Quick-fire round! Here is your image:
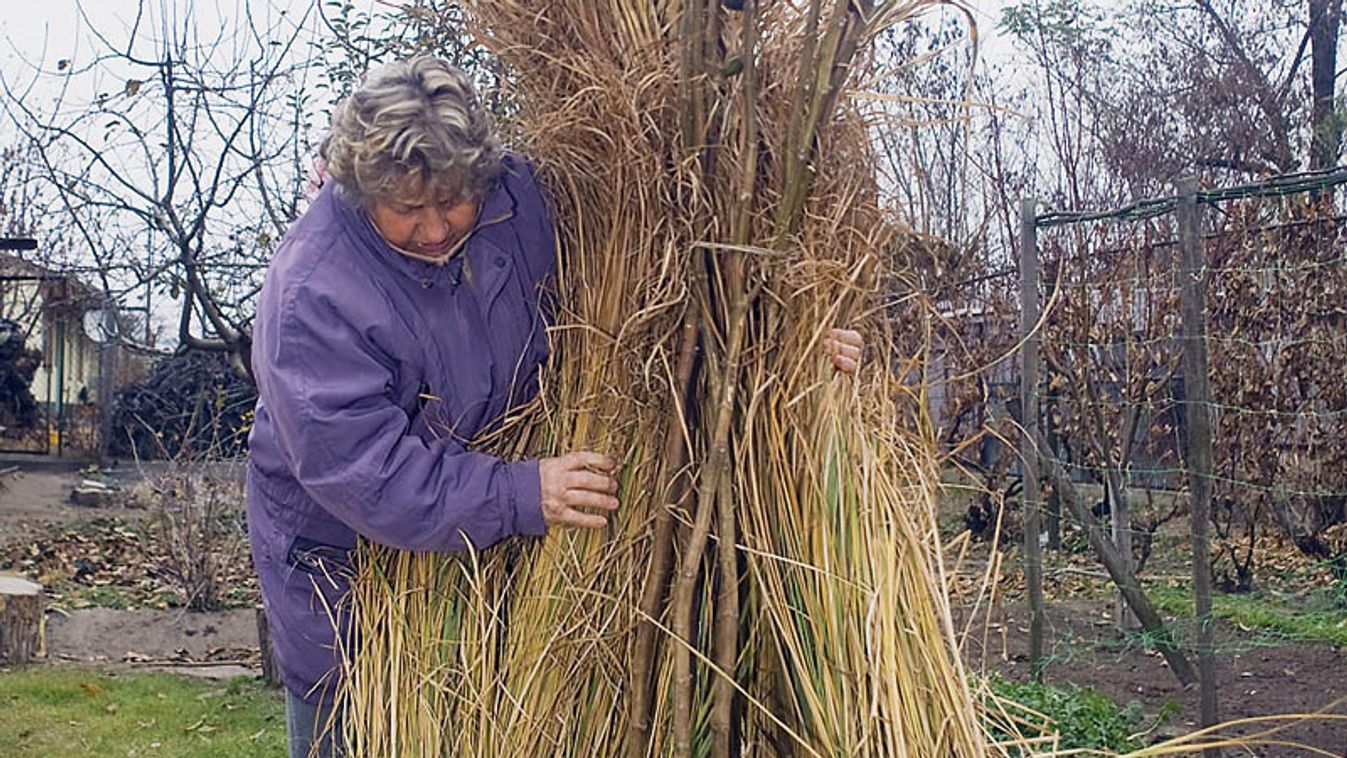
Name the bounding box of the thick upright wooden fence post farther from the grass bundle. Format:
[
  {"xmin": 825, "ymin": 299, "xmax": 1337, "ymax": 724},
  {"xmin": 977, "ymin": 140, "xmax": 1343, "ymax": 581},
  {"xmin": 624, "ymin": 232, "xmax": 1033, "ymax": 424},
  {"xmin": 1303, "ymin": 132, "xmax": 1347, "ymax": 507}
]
[{"xmin": 1177, "ymin": 178, "xmax": 1216, "ymax": 754}]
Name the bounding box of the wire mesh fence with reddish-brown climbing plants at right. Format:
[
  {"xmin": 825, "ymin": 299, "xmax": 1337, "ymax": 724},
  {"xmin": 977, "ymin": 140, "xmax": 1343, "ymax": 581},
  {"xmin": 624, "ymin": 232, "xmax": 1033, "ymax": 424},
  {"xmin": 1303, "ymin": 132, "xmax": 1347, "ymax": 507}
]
[{"xmin": 932, "ymin": 168, "xmax": 1347, "ymax": 723}]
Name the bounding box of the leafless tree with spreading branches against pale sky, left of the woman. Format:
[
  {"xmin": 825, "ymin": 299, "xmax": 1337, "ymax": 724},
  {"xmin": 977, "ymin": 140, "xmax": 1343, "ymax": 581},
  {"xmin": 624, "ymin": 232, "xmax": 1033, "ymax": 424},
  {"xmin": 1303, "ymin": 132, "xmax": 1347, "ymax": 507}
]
[{"xmin": 4, "ymin": 3, "xmax": 319, "ymax": 377}]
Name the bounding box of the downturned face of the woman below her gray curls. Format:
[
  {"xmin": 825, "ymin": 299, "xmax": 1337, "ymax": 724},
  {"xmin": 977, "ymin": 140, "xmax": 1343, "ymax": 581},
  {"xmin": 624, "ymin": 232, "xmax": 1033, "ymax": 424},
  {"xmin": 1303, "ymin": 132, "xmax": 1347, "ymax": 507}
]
[{"xmin": 369, "ymin": 182, "xmax": 478, "ymax": 259}]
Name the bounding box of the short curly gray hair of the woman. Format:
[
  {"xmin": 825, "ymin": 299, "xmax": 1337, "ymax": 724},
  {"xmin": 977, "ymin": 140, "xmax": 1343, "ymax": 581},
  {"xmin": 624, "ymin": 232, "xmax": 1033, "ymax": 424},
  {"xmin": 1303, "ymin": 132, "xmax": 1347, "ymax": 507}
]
[{"xmin": 321, "ymin": 55, "xmax": 501, "ymax": 207}]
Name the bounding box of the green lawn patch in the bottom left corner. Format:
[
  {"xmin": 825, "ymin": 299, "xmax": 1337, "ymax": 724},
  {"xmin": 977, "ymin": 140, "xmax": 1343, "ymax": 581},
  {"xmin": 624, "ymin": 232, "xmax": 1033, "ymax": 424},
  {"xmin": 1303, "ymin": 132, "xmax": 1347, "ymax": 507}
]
[{"xmin": 0, "ymin": 666, "xmax": 286, "ymax": 758}]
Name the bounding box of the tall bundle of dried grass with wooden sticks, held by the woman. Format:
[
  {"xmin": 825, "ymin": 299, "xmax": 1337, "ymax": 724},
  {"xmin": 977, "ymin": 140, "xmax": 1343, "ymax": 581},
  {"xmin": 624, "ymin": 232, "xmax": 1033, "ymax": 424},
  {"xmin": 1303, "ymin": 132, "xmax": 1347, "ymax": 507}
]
[{"xmin": 336, "ymin": 0, "xmax": 987, "ymax": 757}]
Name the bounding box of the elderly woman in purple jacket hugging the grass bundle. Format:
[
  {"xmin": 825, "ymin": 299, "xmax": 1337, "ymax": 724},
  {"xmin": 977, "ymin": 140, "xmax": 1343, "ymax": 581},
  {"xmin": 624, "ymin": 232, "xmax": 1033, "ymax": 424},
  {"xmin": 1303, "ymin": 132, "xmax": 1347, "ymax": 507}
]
[{"xmin": 248, "ymin": 58, "xmax": 859, "ymax": 755}]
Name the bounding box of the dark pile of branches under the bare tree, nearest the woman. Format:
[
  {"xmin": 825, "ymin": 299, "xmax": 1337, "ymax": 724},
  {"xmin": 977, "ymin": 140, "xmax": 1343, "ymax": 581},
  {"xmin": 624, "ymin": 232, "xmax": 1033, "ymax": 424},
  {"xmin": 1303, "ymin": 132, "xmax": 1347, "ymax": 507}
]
[{"xmin": 109, "ymin": 350, "xmax": 257, "ymax": 459}]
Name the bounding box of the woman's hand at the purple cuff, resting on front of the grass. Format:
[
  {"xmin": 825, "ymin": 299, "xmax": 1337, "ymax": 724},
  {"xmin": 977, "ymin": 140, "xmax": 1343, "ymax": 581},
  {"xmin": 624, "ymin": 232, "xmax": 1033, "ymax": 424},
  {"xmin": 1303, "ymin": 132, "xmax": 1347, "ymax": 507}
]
[{"xmin": 537, "ymin": 452, "xmax": 617, "ymax": 529}]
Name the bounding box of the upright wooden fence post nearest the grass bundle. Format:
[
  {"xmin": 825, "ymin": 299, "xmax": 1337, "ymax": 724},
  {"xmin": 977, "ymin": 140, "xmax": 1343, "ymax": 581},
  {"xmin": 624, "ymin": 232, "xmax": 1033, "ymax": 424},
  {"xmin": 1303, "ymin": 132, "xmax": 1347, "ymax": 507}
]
[{"xmin": 1020, "ymin": 198, "xmax": 1044, "ymax": 679}]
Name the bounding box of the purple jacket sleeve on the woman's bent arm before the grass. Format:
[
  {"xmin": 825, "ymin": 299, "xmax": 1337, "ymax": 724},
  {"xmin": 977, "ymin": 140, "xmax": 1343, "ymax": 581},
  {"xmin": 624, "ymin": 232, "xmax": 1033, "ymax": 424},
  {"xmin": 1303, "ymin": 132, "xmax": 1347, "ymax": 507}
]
[{"xmin": 259, "ymin": 285, "xmax": 547, "ymax": 551}]
